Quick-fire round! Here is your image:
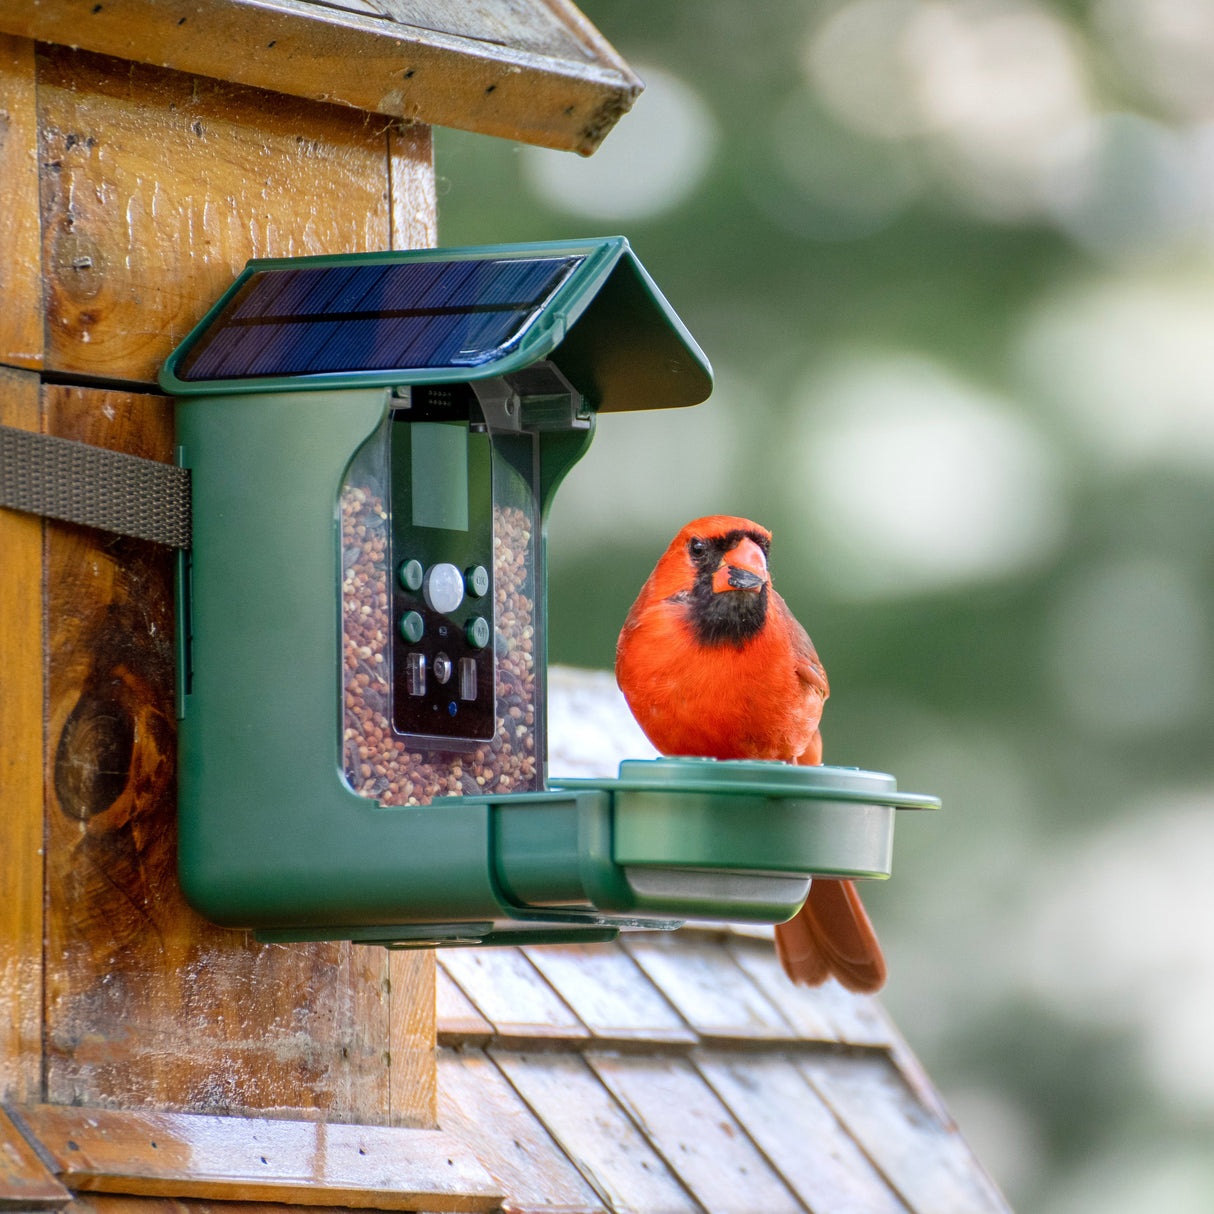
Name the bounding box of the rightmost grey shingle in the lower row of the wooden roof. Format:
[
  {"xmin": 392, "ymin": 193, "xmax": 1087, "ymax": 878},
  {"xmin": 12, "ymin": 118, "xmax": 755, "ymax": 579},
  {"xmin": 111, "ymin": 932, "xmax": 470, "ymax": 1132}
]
[{"xmin": 799, "ymin": 1056, "xmax": 1010, "ymax": 1214}]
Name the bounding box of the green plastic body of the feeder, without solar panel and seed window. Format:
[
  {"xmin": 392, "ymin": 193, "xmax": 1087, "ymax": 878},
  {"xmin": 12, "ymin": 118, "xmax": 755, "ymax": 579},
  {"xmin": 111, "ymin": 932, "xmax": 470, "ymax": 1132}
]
[{"xmin": 161, "ymin": 238, "xmax": 936, "ymax": 947}]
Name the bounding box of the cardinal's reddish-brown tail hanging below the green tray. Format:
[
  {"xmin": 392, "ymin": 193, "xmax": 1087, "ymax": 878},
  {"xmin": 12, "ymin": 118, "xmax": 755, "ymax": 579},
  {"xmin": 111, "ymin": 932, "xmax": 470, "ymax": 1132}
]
[{"xmin": 776, "ymin": 877, "xmax": 885, "ymax": 994}]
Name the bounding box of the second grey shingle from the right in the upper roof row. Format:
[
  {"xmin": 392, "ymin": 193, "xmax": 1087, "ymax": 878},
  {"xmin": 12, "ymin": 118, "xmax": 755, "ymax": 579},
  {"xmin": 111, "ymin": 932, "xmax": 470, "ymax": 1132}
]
[{"xmin": 620, "ymin": 932, "xmax": 796, "ymax": 1042}]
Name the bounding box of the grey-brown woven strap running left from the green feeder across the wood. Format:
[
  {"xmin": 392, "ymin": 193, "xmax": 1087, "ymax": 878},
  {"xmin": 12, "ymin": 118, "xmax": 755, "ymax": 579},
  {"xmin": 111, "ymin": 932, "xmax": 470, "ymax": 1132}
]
[{"xmin": 0, "ymin": 426, "xmax": 191, "ymax": 548}]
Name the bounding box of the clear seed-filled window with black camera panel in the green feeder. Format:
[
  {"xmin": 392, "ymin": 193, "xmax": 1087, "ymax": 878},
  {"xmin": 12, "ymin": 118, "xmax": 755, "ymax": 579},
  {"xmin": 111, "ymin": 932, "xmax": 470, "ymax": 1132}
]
[{"xmin": 339, "ymin": 385, "xmax": 545, "ymax": 805}]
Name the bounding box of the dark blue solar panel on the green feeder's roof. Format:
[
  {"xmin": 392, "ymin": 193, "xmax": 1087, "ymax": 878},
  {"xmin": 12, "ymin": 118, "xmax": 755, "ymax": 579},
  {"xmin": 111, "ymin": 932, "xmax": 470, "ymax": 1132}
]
[{"xmin": 178, "ymin": 256, "xmax": 585, "ymax": 381}]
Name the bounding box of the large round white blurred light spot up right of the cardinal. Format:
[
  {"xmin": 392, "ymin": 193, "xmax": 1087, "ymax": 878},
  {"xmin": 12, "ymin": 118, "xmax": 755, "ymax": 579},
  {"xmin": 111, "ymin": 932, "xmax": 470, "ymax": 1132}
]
[{"xmin": 787, "ymin": 354, "xmax": 1066, "ymax": 596}]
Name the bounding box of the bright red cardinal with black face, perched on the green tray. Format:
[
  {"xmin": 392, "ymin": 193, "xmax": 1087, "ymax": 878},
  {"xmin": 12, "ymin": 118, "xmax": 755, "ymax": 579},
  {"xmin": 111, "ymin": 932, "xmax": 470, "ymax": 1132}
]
[{"xmin": 615, "ymin": 515, "xmax": 885, "ymax": 994}]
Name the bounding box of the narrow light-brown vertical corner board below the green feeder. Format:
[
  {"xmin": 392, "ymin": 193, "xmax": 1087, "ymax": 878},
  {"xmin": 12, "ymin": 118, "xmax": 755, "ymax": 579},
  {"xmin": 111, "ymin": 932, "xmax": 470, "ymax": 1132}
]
[{"xmin": 388, "ymin": 951, "xmax": 438, "ymax": 1129}]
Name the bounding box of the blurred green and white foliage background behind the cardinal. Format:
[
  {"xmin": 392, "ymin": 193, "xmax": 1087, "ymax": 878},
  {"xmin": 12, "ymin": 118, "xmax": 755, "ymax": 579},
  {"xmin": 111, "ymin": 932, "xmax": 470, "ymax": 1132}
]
[{"xmin": 437, "ymin": 0, "xmax": 1214, "ymax": 1214}]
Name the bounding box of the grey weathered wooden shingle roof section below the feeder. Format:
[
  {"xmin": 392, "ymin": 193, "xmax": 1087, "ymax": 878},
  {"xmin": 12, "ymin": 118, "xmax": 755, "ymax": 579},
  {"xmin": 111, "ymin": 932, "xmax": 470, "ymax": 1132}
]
[{"xmin": 438, "ymin": 927, "xmax": 1008, "ymax": 1214}]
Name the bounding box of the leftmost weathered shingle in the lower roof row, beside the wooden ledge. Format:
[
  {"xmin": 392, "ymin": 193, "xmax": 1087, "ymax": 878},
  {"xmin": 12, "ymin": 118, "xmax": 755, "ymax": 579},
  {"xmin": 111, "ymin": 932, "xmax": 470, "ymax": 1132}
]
[{"xmin": 438, "ymin": 1050, "xmax": 607, "ymax": 1214}]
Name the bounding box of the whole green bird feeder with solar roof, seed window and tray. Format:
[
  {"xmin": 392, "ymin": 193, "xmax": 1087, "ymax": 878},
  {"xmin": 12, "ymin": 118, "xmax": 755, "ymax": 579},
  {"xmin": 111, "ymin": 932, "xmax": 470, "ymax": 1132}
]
[{"xmin": 161, "ymin": 231, "xmax": 934, "ymax": 947}]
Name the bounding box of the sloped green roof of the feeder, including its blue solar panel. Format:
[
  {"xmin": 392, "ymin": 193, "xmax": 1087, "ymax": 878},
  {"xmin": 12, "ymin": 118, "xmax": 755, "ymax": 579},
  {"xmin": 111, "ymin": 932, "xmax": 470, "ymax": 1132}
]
[{"xmin": 160, "ymin": 237, "xmax": 713, "ymax": 412}]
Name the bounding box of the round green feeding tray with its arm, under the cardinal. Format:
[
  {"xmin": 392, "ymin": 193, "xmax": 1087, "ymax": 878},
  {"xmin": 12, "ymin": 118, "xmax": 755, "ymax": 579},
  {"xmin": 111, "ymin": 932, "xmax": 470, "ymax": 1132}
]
[{"xmin": 497, "ymin": 758, "xmax": 940, "ymax": 923}]
